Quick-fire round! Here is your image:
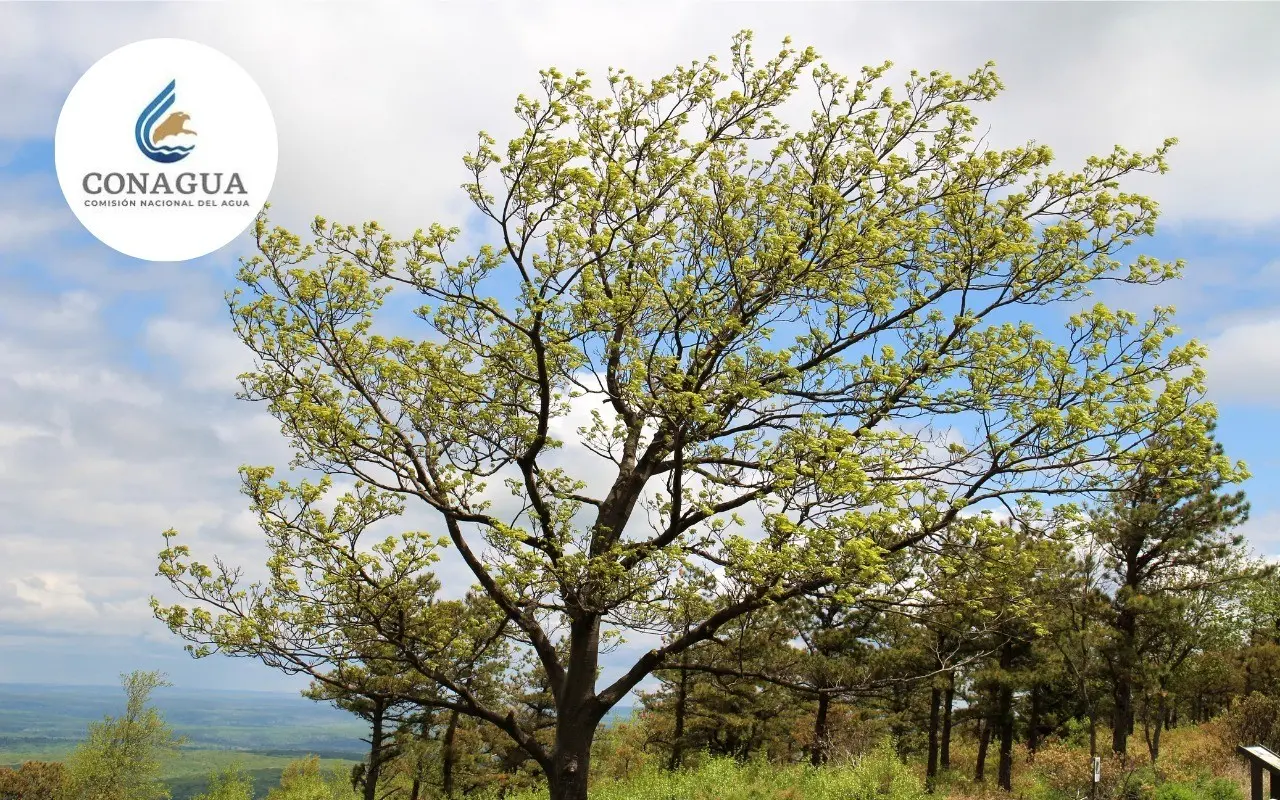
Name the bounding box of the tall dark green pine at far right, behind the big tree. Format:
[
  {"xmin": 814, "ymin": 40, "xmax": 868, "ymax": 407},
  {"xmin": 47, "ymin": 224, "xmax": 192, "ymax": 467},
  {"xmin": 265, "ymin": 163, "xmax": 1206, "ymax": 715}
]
[{"xmin": 1092, "ymin": 421, "xmax": 1254, "ymax": 759}]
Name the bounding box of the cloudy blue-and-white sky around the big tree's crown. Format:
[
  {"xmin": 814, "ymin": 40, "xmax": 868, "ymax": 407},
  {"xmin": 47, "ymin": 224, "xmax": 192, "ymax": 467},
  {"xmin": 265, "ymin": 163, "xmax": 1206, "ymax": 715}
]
[{"xmin": 0, "ymin": 3, "xmax": 1280, "ymax": 689}]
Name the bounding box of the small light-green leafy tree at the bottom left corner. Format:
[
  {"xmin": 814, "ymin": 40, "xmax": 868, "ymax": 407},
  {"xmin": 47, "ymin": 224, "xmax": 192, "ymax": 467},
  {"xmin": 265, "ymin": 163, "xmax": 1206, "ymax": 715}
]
[{"xmin": 58, "ymin": 672, "xmax": 184, "ymax": 800}]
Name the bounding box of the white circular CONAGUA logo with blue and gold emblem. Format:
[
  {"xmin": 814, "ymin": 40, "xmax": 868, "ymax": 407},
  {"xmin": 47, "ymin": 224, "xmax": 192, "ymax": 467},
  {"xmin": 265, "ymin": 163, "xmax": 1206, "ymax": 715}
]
[{"xmin": 54, "ymin": 38, "xmax": 279, "ymax": 261}]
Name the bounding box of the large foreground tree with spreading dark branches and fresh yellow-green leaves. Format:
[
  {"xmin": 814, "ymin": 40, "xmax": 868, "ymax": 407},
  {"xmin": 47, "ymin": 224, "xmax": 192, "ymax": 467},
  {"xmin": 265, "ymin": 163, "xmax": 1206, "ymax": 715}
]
[{"xmin": 154, "ymin": 35, "xmax": 1202, "ymax": 800}]
